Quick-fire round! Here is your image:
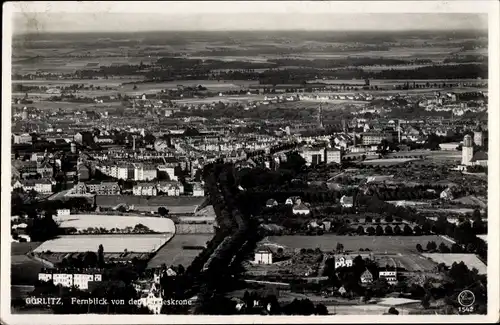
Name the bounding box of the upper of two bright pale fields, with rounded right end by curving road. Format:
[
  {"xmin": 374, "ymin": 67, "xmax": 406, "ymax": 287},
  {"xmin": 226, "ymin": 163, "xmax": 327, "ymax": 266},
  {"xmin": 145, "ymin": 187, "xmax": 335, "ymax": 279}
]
[{"xmin": 54, "ymin": 214, "xmax": 175, "ymax": 233}]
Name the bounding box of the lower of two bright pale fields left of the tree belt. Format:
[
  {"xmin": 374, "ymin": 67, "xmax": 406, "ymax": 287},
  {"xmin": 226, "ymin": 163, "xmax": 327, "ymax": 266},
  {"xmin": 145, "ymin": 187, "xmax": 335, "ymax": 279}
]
[{"xmin": 34, "ymin": 234, "xmax": 173, "ymax": 253}]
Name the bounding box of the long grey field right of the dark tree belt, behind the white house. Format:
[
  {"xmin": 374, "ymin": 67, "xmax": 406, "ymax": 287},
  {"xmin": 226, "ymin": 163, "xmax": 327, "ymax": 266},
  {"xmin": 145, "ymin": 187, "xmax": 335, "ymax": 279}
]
[{"xmin": 261, "ymin": 234, "xmax": 446, "ymax": 253}]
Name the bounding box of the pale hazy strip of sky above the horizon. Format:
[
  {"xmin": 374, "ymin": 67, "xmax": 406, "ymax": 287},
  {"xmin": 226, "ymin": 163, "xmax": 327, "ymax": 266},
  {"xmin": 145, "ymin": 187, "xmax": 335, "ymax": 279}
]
[{"xmin": 14, "ymin": 12, "xmax": 488, "ymax": 33}]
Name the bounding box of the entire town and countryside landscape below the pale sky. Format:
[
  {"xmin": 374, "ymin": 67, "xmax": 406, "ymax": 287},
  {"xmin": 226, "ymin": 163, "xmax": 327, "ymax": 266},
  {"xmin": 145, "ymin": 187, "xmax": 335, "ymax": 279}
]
[{"xmin": 9, "ymin": 12, "xmax": 489, "ymax": 315}]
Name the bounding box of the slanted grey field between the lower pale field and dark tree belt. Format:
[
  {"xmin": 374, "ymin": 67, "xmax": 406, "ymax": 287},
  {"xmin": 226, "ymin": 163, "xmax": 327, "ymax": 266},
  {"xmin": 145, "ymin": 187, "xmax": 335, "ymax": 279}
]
[{"xmin": 148, "ymin": 234, "xmax": 212, "ymax": 268}]
